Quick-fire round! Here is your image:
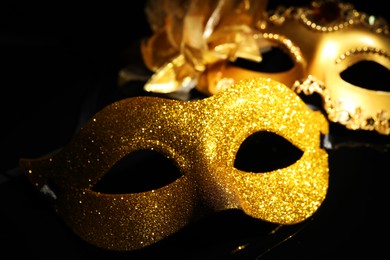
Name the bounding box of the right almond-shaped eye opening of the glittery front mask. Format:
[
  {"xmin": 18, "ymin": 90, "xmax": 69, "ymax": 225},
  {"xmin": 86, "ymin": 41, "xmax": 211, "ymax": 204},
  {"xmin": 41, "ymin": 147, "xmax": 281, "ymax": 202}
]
[{"xmin": 234, "ymin": 131, "xmax": 303, "ymax": 173}]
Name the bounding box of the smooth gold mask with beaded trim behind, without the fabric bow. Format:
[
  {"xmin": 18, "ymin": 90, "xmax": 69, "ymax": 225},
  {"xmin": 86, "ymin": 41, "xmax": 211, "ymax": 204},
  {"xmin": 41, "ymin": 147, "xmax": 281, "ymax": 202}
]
[{"xmin": 198, "ymin": 0, "xmax": 390, "ymax": 135}]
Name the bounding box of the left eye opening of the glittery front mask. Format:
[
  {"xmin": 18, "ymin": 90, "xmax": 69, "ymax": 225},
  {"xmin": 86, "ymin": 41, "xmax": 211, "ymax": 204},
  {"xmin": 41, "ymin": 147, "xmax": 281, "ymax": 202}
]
[{"xmin": 91, "ymin": 149, "xmax": 182, "ymax": 194}]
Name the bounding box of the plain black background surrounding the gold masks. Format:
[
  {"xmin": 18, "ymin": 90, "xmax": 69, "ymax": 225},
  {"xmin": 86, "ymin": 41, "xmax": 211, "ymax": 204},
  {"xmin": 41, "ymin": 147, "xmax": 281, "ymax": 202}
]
[{"xmin": 0, "ymin": 0, "xmax": 390, "ymax": 259}]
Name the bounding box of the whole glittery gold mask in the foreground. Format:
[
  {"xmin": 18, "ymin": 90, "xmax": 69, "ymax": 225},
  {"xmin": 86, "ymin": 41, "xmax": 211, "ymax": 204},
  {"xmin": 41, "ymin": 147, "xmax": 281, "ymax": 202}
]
[{"xmin": 20, "ymin": 79, "xmax": 328, "ymax": 251}]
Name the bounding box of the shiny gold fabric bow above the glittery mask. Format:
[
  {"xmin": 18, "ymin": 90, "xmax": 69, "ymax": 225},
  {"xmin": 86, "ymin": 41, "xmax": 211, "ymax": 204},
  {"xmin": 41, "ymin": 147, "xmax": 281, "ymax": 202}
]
[{"xmin": 120, "ymin": 0, "xmax": 267, "ymax": 96}]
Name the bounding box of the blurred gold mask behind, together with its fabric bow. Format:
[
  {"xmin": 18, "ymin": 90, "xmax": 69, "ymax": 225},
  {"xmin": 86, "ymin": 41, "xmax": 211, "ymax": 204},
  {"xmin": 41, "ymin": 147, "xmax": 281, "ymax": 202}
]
[{"xmin": 124, "ymin": 0, "xmax": 390, "ymax": 135}]
